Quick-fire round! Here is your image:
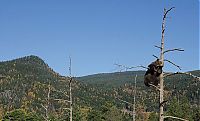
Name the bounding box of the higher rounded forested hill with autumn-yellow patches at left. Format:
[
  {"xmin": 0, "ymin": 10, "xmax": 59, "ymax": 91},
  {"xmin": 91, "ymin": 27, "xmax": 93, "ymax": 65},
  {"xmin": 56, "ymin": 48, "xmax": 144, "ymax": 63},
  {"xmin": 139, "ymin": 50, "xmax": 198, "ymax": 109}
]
[{"xmin": 0, "ymin": 55, "xmax": 77, "ymax": 120}]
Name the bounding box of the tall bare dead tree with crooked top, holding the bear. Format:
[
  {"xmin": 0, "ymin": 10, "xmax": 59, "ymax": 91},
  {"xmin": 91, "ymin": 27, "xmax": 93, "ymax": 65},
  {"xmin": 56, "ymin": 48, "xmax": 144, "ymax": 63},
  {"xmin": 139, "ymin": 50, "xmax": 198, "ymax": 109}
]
[{"xmin": 115, "ymin": 7, "xmax": 200, "ymax": 121}]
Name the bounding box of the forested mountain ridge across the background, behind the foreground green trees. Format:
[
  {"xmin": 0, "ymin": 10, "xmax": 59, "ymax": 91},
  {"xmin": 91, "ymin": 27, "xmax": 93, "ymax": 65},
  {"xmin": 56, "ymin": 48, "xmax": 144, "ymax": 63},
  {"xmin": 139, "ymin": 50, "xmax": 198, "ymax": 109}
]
[{"xmin": 0, "ymin": 56, "xmax": 200, "ymax": 120}]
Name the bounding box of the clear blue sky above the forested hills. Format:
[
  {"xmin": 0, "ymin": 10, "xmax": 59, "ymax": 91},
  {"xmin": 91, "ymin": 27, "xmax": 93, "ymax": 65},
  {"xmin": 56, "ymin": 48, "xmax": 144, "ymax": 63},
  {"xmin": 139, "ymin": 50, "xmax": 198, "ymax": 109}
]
[{"xmin": 0, "ymin": 0, "xmax": 199, "ymax": 76}]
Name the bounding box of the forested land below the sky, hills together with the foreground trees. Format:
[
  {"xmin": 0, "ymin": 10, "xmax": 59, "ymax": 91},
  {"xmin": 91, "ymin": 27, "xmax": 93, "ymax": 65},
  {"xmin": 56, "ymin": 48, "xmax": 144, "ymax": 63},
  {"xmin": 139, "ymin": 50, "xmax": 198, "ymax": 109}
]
[{"xmin": 0, "ymin": 56, "xmax": 200, "ymax": 121}]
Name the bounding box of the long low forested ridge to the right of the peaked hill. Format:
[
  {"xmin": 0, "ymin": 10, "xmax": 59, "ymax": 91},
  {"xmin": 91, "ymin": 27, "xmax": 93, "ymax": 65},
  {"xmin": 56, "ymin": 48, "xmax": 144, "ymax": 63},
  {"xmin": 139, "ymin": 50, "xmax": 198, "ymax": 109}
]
[{"xmin": 77, "ymin": 70, "xmax": 200, "ymax": 108}]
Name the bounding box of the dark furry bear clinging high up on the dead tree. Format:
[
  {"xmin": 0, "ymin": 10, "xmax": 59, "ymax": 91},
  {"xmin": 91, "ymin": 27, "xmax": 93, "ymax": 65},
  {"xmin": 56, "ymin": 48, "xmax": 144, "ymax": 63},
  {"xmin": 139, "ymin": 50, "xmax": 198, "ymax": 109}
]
[{"xmin": 144, "ymin": 59, "xmax": 163, "ymax": 87}]
